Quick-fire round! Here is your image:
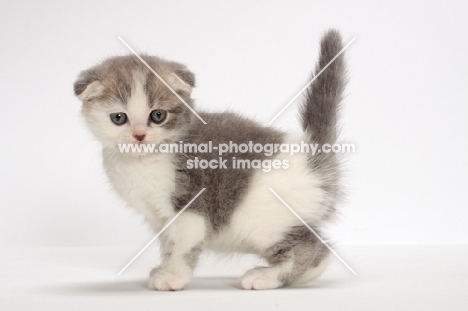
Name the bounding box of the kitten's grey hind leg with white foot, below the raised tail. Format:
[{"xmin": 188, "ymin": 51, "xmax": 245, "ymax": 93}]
[{"xmin": 241, "ymin": 227, "xmax": 323, "ymax": 289}]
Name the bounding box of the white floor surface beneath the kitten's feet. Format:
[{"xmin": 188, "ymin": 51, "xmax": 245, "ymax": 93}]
[{"xmin": 0, "ymin": 245, "xmax": 468, "ymax": 311}]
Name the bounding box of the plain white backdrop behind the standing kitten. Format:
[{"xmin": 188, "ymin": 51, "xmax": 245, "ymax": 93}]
[{"xmin": 0, "ymin": 0, "xmax": 468, "ymax": 247}]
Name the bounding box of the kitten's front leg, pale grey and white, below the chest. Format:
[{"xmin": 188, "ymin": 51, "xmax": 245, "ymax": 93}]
[{"xmin": 148, "ymin": 211, "xmax": 205, "ymax": 290}]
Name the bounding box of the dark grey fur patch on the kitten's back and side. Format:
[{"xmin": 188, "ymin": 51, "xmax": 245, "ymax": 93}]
[{"xmin": 173, "ymin": 113, "xmax": 284, "ymax": 231}]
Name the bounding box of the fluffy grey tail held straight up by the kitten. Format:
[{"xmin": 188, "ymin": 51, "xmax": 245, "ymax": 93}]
[{"xmin": 301, "ymin": 30, "xmax": 346, "ymax": 145}]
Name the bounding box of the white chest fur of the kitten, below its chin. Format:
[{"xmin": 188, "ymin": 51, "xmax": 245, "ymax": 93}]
[{"xmin": 103, "ymin": 149, "xmax": 175, "ymax": 227}]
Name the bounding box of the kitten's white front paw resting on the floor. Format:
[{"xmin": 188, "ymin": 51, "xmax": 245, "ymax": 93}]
[{"xmin": 148, "ymin": 268, "xmax": 191, "ymax": 291}]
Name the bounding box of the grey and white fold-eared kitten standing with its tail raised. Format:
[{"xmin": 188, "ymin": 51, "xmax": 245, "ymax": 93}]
[{"xmin": 74, "ymin": 30, "xmax": 345, "ymax": 290}]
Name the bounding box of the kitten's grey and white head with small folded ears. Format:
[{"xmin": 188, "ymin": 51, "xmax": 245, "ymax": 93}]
[{"xmin": 74, "ymin": 55, "xmax": 195, "ymax": 153}]
